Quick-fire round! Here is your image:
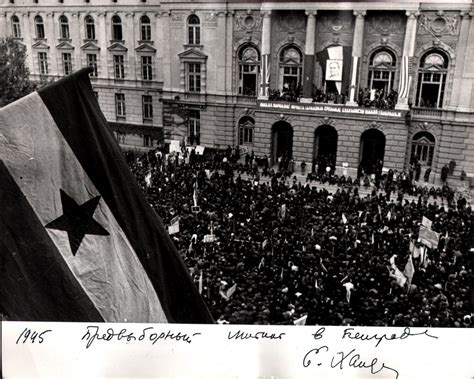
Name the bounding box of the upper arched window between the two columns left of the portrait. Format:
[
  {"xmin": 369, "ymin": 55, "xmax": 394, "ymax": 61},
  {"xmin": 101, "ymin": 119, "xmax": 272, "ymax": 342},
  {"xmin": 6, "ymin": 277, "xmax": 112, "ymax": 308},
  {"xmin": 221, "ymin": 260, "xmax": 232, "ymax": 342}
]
[{"xmin": 280, "ymin": 46, "xmax": 303, "ymax": 93}]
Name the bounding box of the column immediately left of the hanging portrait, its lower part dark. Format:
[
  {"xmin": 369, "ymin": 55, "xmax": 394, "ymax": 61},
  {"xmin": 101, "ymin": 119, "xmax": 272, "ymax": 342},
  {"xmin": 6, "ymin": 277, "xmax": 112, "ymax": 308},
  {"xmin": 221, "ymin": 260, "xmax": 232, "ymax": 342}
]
[{"xmin": 301, "ymin": 11, "xmax": 318, "ymax": 103}]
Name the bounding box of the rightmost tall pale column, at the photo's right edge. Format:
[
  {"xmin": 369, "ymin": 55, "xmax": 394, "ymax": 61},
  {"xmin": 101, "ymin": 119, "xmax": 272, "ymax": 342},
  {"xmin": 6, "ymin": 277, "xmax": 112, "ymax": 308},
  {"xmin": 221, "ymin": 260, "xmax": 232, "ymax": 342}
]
[{"xmin": 449, "ymin": 11, "xmax": 473, "ymax": 111}]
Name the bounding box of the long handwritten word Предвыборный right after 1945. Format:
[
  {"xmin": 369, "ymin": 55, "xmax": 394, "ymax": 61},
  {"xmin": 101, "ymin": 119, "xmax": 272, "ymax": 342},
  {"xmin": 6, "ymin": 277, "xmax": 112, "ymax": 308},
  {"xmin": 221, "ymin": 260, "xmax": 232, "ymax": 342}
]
[{"xmin": 81, "ymin": 326, "xmax": 201, "ymax": 349}]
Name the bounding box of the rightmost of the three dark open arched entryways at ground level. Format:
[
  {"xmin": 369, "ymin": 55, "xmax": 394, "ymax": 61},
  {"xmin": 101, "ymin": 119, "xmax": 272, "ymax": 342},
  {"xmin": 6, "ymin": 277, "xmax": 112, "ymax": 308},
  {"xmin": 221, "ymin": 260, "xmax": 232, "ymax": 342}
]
[{"xmin": 359, "ymin": 129, "xmax": 385, "ymax": 176}]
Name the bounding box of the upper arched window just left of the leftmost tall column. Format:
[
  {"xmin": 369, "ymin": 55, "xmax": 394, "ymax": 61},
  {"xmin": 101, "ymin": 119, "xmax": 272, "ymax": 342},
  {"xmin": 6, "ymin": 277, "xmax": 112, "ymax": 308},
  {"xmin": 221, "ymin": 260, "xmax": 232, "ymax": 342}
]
[{"xmin": 239, "ymin": 45, "xmax": 260, "ymax": 96}]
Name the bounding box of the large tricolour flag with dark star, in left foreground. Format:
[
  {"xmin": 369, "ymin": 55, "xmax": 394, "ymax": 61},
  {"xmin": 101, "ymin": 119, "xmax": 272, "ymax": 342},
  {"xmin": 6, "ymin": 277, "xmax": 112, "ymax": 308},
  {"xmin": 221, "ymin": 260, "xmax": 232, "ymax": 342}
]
[{"xmin": 0, "ymin": 69, "xmax": 213, "ymax": 323}]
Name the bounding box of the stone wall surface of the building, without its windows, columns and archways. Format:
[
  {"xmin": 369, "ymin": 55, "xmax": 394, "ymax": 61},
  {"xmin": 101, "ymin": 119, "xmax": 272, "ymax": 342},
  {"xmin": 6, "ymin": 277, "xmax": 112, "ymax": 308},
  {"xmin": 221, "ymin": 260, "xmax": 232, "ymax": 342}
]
[{"xmin": 0, "ymin": 0, "xmax": 474, "ymax": 181}]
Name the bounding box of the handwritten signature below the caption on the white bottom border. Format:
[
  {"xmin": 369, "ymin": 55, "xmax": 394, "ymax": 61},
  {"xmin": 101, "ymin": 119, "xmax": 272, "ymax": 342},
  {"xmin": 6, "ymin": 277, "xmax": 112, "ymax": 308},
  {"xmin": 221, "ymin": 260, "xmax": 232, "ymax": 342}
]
[{"xmin": 303, "ymin": 345, "xmax": 399, "ymax": 379}]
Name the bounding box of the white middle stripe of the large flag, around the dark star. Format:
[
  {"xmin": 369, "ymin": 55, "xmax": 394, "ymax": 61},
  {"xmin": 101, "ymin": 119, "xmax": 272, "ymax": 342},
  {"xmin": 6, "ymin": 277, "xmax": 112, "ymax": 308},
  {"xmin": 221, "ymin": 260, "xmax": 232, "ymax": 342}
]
[{"xmin": 0, "ymin": 93, "xmax": 167, "ymax": 322}]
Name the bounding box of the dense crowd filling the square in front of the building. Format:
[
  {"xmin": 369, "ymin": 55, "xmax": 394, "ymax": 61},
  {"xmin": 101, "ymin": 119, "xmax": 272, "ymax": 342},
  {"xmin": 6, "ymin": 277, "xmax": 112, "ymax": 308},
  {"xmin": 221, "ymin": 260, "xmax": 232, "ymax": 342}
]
[{"xmin": 128, "ymin": 147, "xmax": 474, "ymax": 327}]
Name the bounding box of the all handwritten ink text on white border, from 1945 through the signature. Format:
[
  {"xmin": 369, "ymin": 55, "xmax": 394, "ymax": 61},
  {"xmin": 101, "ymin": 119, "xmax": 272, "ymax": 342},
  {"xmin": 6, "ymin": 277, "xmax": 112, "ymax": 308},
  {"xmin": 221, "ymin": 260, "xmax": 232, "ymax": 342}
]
[{"xmin": 12, "ymin": 325, "xmax": 438, "ymax": 379}]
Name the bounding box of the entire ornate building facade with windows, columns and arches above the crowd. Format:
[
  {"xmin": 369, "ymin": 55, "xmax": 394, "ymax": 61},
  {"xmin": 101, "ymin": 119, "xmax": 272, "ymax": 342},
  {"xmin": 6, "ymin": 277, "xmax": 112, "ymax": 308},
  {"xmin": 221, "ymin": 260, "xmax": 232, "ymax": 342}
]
[{"xmin": 0, "ymin": 0, "xmax": 474, "ymax": 181}]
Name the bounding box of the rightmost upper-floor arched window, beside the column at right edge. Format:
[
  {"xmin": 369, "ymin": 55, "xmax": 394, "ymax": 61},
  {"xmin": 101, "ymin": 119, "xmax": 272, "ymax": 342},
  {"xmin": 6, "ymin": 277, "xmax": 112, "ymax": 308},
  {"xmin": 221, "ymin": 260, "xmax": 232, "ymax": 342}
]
[{"xmin": 415, "ymin": 50, "xmax": 449, "ymax": 108}]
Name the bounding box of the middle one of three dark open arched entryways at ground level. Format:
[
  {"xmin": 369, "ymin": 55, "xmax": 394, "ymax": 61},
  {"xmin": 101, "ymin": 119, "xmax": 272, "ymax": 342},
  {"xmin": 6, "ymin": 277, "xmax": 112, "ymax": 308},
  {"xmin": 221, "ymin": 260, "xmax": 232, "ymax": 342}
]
[{"xmin": 313, "ymin": 125, "xmax": 337, "ymax": 174}]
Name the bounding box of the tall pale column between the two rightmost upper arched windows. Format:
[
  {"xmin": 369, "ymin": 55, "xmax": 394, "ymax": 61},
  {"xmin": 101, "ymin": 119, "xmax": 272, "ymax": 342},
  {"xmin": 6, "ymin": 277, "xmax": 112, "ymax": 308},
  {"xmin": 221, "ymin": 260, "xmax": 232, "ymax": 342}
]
[{"xmin": 395, "ymin": 11, "xmax": 419, "ymax": 110}]
